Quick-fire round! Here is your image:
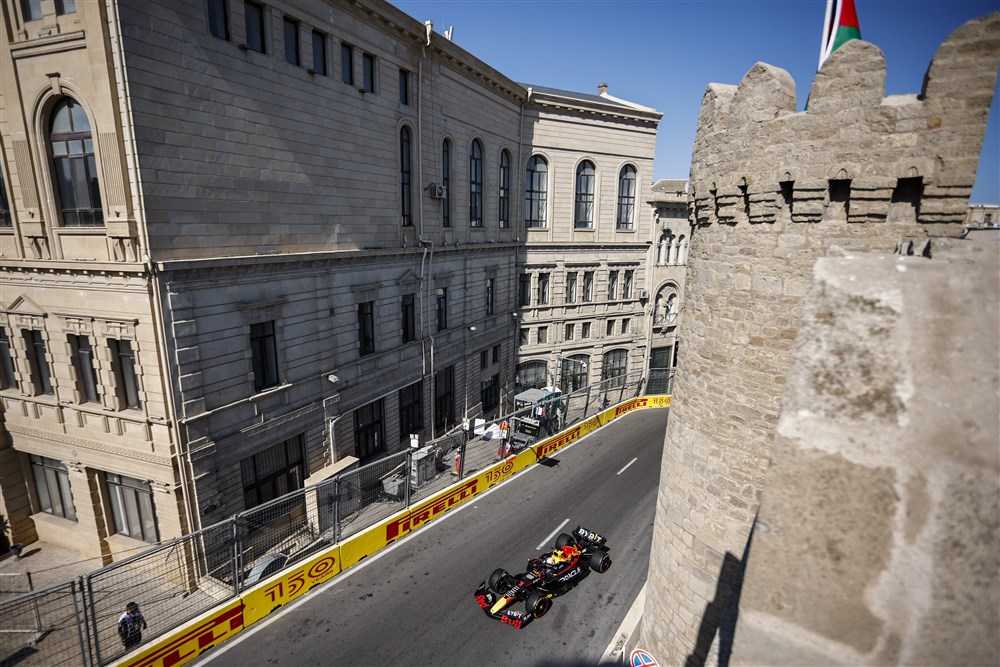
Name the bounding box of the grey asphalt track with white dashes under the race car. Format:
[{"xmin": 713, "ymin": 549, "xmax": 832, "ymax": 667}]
[{"xmin": 195, "ymin": 409, "xmax": 667, "ymax": 667}]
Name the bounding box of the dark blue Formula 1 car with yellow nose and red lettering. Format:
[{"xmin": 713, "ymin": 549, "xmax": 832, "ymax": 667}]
[{"xmin": 476, "ymin": 526, "xmax": 611, "ymax": 628}]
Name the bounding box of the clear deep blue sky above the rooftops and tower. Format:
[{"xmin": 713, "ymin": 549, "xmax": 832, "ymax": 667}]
[{"xmin": 391, "ymin": 0, "xmax": 1000, "ymax": 204}]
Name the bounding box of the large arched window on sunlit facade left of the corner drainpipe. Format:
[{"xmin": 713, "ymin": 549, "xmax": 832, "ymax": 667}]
[{"xmin": 49, "ymin": 97, "xmax": 104, "ymax": 227}]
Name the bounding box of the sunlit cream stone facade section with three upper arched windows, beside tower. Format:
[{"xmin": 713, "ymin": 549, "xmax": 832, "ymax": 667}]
[{"xmin": 517, "ymin": 85, "xmax": 661, "ymax": 392}]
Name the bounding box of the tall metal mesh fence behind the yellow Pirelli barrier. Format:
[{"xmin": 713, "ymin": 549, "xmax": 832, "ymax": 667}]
[{"xmin": 0, "ymin": 369, "xmax": 673, "ymax": 667}]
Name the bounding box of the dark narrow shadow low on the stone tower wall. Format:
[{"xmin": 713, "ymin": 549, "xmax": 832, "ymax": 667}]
[{"xmin": 684, "ymin": 517, "xmax": 757, "ymax": 667}]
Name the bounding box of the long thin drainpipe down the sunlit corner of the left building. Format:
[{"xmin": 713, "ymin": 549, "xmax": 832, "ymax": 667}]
[{"xmin": 110, "ymin": 2, "xmax": 201, "ymax": 533}]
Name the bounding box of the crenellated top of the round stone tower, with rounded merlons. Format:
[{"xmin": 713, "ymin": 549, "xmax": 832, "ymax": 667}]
[{"xmin": 691, "ymin": 13, "xmax": 1000, "ymax": 236}]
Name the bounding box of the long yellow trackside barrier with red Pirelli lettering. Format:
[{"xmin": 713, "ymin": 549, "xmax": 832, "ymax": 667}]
[{"xmin": 115, "ymin": 396, "xmax": 670, "ymax": 667}]
